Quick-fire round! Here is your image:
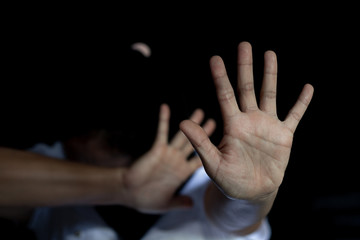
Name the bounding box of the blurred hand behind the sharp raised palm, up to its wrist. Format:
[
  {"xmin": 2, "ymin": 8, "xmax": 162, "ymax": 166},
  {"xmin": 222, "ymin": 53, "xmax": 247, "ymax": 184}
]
[{"xmin": 124, "ymin": 104, "xmax": 215, "ymax": 213}]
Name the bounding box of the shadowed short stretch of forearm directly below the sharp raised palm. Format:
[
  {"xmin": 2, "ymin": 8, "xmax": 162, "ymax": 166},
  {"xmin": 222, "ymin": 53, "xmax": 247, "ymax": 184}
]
[{"xmin": 204, "ymin": 183, "xmax": 276, "ymax": 235}]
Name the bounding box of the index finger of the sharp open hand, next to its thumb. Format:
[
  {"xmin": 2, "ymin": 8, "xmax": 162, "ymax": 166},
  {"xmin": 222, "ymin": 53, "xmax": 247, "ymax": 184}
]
[{"xmin": 210, "ymin": 56, "xmax": 239, "ymax": 119}]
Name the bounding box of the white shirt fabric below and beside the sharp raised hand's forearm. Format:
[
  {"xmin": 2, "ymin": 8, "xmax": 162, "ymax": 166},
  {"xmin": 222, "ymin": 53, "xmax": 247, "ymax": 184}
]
[{"xmin": 143, "ymin": 168, "xmax": 271, "ymax": 240}]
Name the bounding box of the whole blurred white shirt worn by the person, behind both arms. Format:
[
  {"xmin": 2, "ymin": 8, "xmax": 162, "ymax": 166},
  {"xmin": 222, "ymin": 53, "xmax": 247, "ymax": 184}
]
[{"xmin": 29, "ymin": 142, "xmax": 271, "ymax": 240}]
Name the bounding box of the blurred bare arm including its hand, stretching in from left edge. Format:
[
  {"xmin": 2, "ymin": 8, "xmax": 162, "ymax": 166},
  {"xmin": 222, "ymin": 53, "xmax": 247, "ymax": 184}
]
[{"xmin": 0, "ymin": 104, "xmax": 215, "ymax": 212}]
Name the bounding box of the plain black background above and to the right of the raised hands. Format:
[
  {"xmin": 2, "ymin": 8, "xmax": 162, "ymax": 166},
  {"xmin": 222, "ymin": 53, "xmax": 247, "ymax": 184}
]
[{"xmin": 0, "ymin": 6, "xmax": 360, "ymax": 239}]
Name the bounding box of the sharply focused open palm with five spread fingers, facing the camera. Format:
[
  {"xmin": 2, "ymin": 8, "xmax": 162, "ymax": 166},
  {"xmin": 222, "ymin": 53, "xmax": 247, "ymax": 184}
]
[{"xmin": 180, "ymin": 42, "xmax": 314, "ymax": 200}]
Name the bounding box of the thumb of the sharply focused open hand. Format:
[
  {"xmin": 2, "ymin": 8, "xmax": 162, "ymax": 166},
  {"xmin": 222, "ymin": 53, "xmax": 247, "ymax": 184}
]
[{"xmin": 180, "ymin": 120, "xmax": 220, "ymax": 175}]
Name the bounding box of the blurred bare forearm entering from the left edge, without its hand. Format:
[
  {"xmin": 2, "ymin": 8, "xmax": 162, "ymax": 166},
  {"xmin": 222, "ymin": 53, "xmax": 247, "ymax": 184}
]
[{"xmin": 0, "ymin": 148, "xmax": 125, "ymax": 207}]
